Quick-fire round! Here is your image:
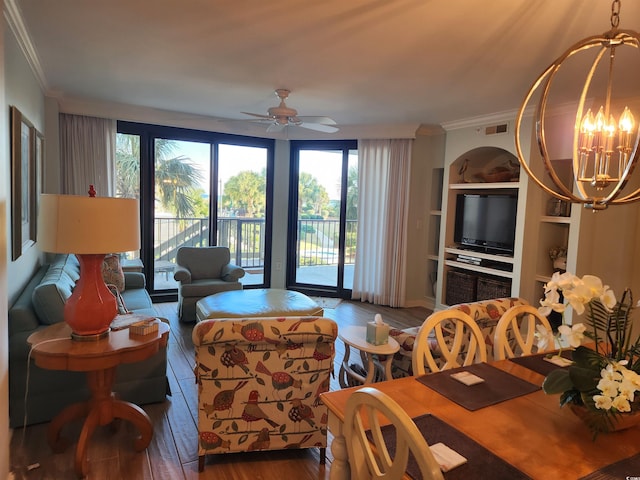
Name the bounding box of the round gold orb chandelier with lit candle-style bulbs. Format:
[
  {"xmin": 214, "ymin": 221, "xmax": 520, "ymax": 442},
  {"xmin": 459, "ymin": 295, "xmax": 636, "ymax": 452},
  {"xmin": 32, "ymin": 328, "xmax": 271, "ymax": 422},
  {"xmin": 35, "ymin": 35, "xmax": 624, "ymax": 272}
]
[{"xmin": 515, "ymin": 0, "xmax": 640, "ymax": 210}]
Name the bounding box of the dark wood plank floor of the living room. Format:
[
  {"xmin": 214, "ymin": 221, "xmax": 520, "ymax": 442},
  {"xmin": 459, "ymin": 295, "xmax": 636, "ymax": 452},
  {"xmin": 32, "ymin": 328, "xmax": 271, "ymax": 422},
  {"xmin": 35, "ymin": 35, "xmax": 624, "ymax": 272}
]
[{"xmin": 10, "ymin": 301, "xmax": 430, "ymax": 480}]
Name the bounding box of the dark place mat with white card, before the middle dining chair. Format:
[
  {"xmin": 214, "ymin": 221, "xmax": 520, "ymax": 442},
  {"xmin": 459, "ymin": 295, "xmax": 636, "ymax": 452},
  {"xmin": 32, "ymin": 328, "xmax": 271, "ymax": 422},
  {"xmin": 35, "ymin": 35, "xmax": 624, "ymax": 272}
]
[{"xmin": 416, "ymin": 363, "xmax": 540, "ymax": 411}]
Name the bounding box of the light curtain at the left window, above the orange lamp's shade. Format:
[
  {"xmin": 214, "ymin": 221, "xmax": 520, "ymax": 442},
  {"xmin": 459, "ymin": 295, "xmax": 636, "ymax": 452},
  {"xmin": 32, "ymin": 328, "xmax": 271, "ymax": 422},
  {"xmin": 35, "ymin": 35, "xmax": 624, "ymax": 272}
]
[{"xmin": 60, "ymin": 113, "xmax": 117, "ymax": 197}]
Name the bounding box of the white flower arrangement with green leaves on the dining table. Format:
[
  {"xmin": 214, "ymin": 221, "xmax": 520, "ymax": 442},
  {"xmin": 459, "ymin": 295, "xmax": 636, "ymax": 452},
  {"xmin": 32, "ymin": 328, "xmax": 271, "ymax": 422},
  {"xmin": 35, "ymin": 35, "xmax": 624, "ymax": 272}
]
[{"xmin": 539, "ymin": 272, "xmax": 640, "ymax": 437}]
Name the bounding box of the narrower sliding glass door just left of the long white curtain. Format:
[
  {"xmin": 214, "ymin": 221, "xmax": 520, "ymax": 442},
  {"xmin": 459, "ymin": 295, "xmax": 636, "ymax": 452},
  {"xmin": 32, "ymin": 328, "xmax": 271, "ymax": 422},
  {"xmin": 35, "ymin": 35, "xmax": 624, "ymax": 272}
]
[{"xmin": 287, "ymin": 141, "xmax": 358, "ymax": 298}]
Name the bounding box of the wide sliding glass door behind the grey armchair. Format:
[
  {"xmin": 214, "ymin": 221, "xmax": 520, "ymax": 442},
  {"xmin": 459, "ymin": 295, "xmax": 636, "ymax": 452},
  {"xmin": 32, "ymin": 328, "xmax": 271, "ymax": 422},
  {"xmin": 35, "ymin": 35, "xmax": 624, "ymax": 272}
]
[{"xmin": 116, "ymin": 122, "xmax": 274, "ymax": 300}]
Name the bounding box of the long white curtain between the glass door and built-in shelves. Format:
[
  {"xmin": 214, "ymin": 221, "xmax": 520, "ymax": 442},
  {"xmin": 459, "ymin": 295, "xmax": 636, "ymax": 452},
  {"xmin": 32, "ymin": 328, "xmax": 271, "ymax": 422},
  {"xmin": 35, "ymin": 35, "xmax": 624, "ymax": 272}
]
[{"xmin": 352, "ymin": 139, "xmax": 413, "ymax": 307}]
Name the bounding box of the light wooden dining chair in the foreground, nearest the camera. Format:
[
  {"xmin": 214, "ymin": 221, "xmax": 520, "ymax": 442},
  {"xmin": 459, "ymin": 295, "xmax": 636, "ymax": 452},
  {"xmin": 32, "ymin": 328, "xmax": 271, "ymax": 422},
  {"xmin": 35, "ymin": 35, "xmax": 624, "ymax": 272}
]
[{"xmin": 344, "ymin": 387, "xmax": 443, "ymax": 480}]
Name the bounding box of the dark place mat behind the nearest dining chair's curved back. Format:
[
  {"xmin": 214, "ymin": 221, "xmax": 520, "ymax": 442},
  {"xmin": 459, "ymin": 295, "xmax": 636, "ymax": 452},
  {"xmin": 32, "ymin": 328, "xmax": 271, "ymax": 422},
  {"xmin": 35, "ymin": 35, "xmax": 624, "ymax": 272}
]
[{"xmin": 369, "ymin": 414, "xmax": 530, "ymax": 480}]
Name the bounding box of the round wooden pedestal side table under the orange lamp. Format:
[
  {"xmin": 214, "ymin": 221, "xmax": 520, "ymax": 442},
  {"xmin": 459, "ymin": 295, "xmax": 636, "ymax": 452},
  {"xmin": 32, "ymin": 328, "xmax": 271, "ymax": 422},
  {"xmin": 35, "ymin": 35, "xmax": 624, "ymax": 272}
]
[{"xmin": 27, "ymin": 321, "xmax": 169, "ymax": 477}]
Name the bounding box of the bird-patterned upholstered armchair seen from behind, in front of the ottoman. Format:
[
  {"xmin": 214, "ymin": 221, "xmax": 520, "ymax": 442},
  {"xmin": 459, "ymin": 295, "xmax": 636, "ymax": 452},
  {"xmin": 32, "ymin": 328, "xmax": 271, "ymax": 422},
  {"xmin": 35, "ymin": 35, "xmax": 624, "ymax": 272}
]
[{"xmin": 192, "ymin": 317, "xmax": 338, "ymax": 471}]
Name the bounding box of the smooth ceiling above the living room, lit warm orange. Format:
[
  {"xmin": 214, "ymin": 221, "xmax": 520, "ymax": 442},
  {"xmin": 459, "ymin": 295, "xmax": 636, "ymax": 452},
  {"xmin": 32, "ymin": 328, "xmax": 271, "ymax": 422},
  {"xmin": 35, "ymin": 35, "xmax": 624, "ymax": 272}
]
[{"xmin": 6, "ymin": 0, "xmax": 640, "ymax": 139}]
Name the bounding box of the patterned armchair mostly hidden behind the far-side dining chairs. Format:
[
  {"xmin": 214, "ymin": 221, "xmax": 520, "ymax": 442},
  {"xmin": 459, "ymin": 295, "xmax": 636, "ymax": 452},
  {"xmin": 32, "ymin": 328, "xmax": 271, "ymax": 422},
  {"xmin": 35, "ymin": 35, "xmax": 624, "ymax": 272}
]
[{"xmin": 389, "ymin": 298, "xmax": 529, "ymax": 378}]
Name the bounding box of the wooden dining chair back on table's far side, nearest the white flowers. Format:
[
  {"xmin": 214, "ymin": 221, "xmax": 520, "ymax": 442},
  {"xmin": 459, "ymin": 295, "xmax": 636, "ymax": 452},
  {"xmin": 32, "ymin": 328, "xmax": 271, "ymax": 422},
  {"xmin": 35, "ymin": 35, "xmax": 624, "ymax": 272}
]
[{"xmin": 493, "ymin": 305, "xmax": 555, "ymax": 360}]
